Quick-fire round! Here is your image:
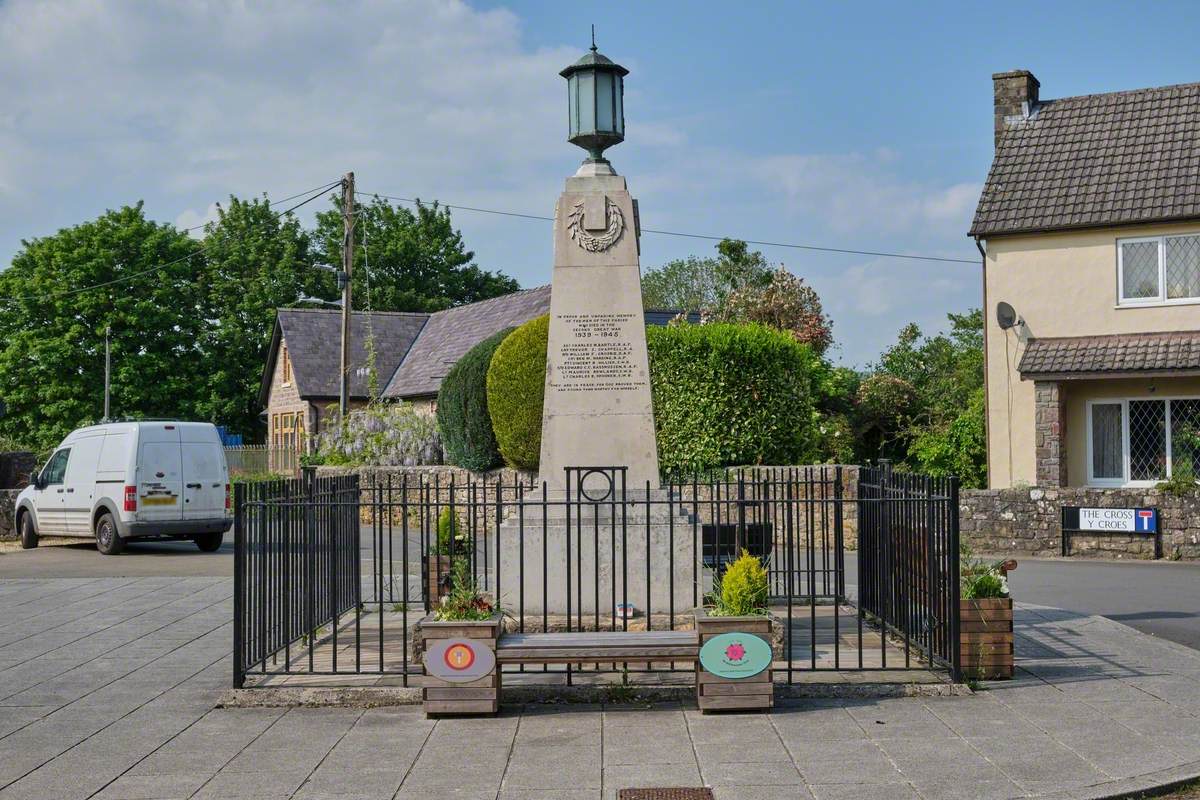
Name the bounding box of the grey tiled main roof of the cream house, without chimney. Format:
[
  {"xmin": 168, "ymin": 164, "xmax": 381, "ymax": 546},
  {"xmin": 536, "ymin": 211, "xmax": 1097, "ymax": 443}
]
[{"xmin": 971, "ymin": 83, "xmax": 1200, "ymax": 236}]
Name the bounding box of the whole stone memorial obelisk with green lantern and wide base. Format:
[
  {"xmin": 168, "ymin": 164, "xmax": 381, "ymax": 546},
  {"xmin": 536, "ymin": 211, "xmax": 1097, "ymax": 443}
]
[{"xmin": 499, "ymin": 42, "xmax": 707, "ymax": 624}]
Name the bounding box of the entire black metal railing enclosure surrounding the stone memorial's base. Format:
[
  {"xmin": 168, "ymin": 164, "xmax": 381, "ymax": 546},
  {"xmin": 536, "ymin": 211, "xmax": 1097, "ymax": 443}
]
[{"xmin": 234, "ymin": 467, "xmax": 958, "ymax": 686}]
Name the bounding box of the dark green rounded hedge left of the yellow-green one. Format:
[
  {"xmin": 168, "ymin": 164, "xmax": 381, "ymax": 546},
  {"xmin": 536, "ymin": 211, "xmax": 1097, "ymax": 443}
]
[{"xmin": 438, "ymin": 327, "xmax": 514, "ymax": 471}]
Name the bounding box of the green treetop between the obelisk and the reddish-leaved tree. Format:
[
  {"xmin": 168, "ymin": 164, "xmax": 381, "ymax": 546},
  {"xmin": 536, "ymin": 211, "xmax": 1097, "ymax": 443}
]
[{"xmin": 642, "ymin": 239, "xmax": 772, "ymax": 313}]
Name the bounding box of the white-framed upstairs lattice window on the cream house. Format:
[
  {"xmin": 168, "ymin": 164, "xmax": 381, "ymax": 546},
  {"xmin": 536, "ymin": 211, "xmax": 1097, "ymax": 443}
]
[{"xmin": 1117, "ymin": 234, "xmax": 1200, "ymax": 306}]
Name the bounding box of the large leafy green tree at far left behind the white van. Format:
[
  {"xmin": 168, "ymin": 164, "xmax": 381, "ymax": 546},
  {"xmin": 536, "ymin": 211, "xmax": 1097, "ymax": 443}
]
[{"xmin": 0, "ymin": 203, "xmax": 206, "ymax": 449}]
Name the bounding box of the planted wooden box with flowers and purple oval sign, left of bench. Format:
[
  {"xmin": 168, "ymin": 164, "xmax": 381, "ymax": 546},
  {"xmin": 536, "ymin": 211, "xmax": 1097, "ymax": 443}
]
[{"xmin": 419, "ymin": 559, "xmax": 502, "ymax": 715}]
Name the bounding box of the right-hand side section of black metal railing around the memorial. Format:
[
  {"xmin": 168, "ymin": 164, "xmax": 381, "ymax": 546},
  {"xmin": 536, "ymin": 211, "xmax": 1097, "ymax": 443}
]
[{"xmin": 858, "ymin": 462, "xmax": 960, "ymax": 676}]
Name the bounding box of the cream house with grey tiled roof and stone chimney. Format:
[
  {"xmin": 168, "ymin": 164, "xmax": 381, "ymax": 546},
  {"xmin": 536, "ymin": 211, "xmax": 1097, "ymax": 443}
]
[{"xmin": 970, "ymin": 70, "xmax": 1200, "ymax": 488}]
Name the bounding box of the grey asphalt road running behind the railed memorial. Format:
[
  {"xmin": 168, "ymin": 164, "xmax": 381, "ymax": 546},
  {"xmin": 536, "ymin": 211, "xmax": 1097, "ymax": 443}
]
[{"xmin": 0, "ymin": 531, "xmax": 1200, "ymax": 650}]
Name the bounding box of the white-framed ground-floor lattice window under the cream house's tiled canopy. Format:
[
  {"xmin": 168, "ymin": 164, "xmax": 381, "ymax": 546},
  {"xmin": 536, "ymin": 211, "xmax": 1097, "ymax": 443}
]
[{"xmin": 1087, "ymin": 397, "xmax": 1200, "ymax": 486}]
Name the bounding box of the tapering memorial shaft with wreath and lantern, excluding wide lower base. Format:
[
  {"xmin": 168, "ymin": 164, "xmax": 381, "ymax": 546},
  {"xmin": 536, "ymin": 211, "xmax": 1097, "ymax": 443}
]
[{"xmin": 539, "ymin": 44, "xmax": 659, "ymax": 492}]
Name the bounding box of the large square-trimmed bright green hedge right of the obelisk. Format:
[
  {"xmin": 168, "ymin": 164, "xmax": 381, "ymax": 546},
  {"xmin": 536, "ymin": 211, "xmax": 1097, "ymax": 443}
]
[{"xmin": 646, "ymin": 324, "xmax": 820, "ymax": 473}]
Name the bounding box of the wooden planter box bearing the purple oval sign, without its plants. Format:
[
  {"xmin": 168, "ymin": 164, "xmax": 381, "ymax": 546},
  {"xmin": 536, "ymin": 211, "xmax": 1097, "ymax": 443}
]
[{"xmin": 419, "ymin": 613, "xmax": 502, "ymax": 716}]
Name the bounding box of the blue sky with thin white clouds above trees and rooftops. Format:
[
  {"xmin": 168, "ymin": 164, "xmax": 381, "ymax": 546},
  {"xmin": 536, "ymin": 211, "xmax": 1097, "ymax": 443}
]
[{"xmin": 0, "ymin": 0, "xmax": 1200, "ymax": 365}]
